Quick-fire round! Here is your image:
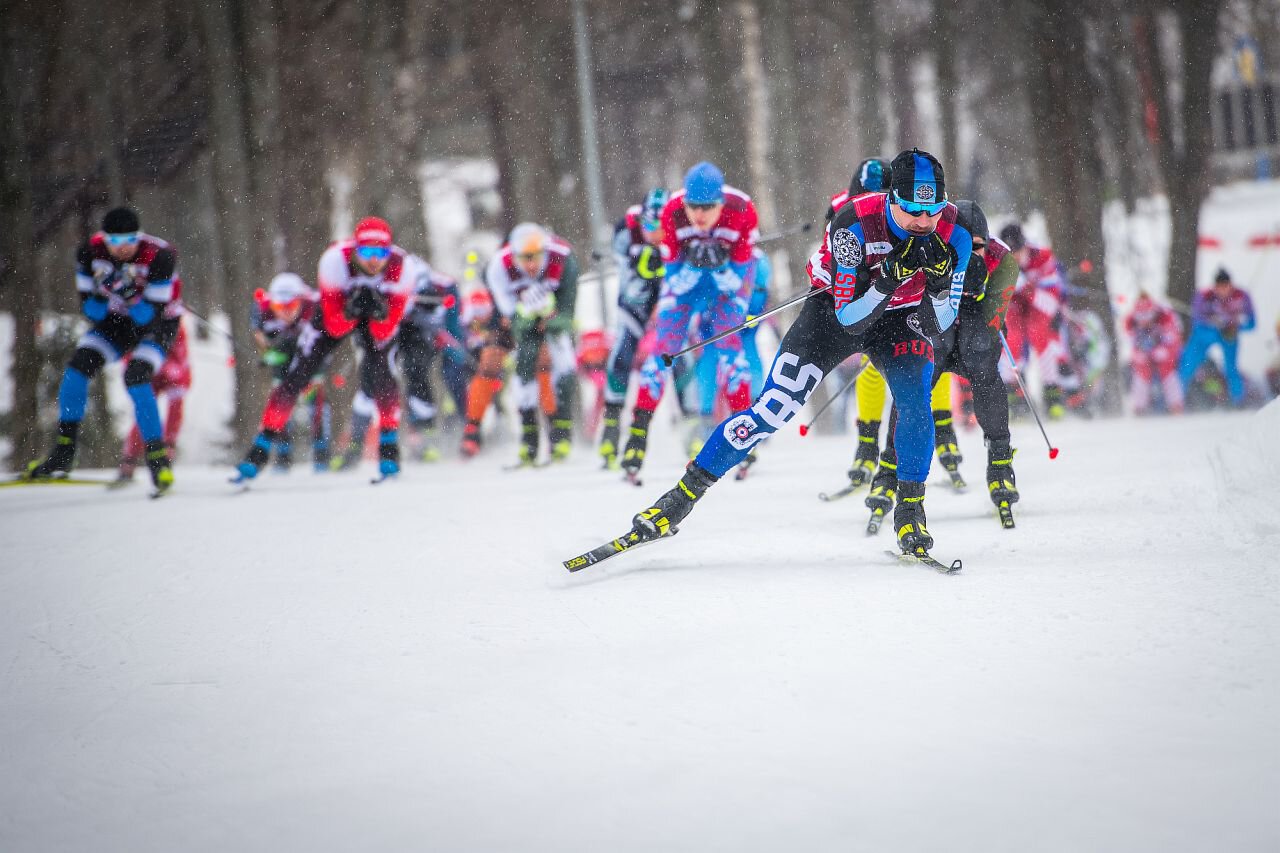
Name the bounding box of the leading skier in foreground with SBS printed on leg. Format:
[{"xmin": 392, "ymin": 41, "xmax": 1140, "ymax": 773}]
[{"xmin": 614, "ymin": 149, "xmax": 972, "ymax": 567}]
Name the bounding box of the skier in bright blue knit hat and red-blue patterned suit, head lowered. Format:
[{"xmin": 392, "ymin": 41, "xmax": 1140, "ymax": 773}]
[{"xmin": 622, "ymin": 161, "xmax": 758, "ymax": 480}]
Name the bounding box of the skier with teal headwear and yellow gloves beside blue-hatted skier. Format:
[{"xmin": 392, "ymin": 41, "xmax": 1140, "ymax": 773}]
[{"xmin": 599, "ymin": 187, "xmax": 667, "ymax": 467}]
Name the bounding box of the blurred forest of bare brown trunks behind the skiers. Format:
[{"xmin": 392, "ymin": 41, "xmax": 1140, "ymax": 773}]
[{"xmin": 0, "ymin": 0, "xmax": 1259, "ymax": 460}]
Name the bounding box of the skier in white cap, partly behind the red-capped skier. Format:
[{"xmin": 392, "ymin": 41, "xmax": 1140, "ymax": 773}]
[{"xmin": 250, "ymin": 273, "xmax": 330, "ymax": 471}]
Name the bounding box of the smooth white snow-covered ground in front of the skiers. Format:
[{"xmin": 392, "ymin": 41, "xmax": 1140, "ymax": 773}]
[{"xmin": 0, "ymin": 403, "xmax": 1280, "ymax": 853}]
